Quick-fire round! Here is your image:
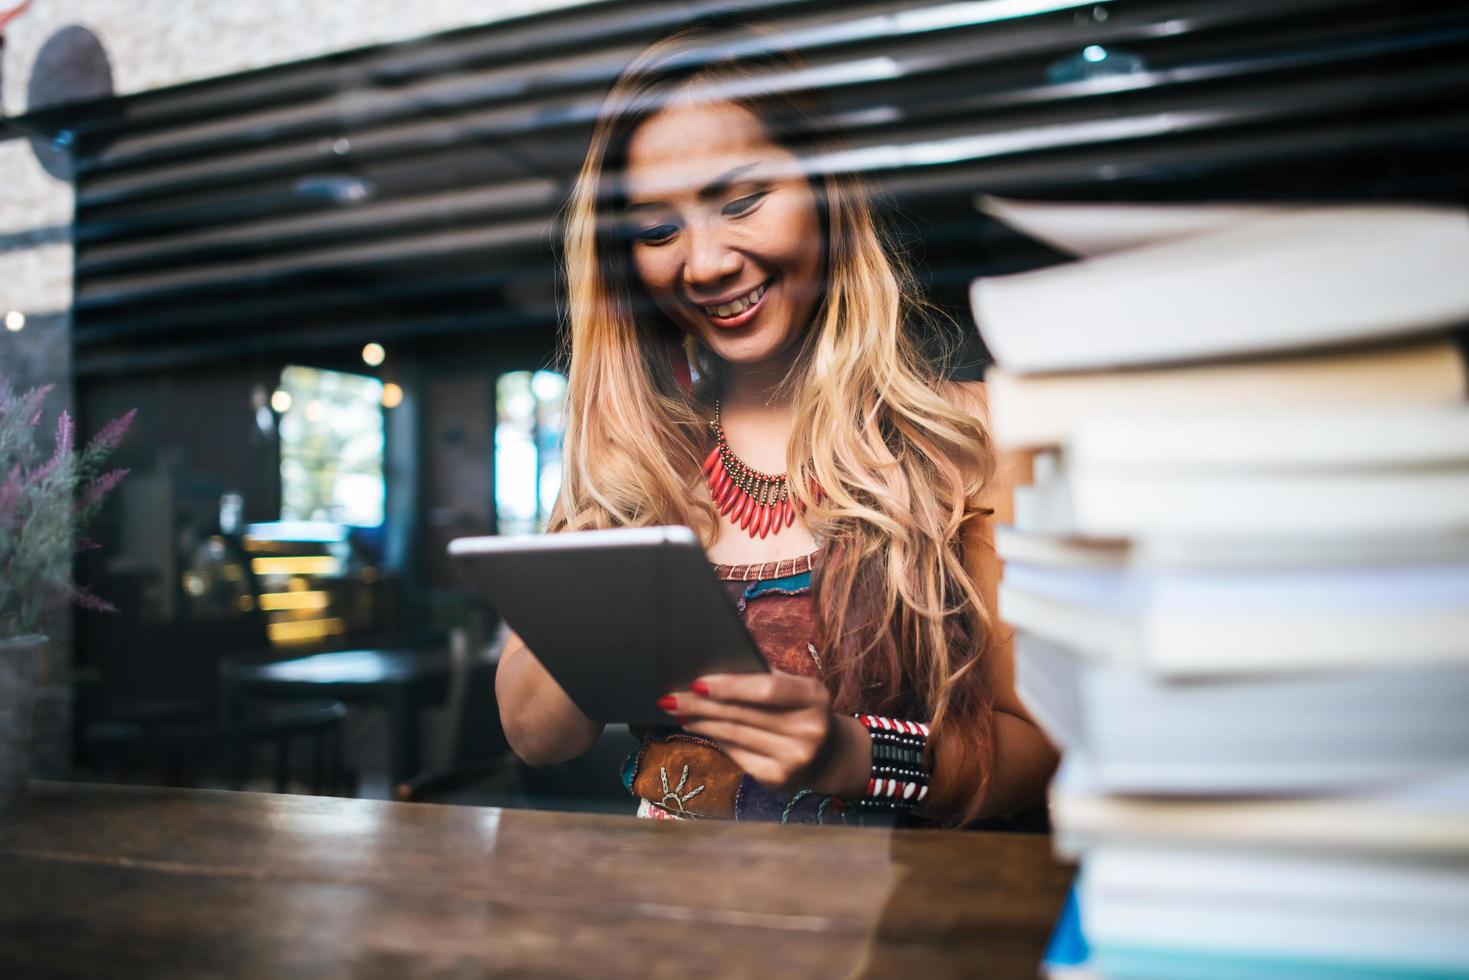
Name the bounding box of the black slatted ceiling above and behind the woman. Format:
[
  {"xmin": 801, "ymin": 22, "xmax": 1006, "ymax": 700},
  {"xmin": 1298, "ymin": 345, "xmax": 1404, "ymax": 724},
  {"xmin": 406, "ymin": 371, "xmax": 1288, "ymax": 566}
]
[{"xmin": 14, "ymin": 0, "xmax": 1469, "ymax": 375}]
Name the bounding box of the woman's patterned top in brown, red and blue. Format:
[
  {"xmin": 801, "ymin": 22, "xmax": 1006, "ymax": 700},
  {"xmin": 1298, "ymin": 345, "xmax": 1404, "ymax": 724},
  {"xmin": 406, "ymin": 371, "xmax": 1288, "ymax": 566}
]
[{"xmin": 623, "ymin": 550, "xmax": 892, "ymax": 824}]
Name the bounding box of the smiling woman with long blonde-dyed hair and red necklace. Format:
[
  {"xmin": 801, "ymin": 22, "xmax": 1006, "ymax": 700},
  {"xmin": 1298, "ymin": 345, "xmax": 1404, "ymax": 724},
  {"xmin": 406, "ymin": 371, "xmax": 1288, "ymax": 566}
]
[{"xmin": 497, "ymin": 26, "xmax": 1055, "ymax": 824}]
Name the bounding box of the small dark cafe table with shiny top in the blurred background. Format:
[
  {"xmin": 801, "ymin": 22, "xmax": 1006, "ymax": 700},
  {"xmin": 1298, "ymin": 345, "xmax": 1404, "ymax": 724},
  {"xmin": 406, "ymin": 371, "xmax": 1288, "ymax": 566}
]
[{"xmin": 223, "ymin": 649, "xmax": 451, "ymax": 786}]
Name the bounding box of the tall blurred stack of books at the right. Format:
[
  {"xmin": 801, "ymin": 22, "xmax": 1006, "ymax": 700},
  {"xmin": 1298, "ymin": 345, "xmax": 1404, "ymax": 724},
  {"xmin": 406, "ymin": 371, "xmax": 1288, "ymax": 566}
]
[{"xmin": 971, "ymin": 198, "xmax": 1469, "ymax": 979}]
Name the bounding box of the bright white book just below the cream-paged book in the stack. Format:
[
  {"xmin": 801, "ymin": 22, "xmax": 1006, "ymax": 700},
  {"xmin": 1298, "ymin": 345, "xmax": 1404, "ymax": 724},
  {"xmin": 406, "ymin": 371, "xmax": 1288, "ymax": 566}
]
[{"xmin": 1064, "ymin": 406, "xmax": 1469, "ymax": 538}]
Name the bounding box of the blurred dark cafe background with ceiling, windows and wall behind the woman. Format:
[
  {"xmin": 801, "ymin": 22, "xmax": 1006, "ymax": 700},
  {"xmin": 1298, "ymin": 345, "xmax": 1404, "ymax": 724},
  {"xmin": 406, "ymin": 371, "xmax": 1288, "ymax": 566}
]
[{"xmin": 0, "ymin": 0, "xmax": 1469, "ymax": 813}]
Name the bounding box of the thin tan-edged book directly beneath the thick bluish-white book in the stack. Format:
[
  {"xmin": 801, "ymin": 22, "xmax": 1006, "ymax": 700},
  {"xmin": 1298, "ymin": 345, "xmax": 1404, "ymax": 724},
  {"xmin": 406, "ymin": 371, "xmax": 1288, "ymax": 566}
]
[{"xmin": 1049, "ymin": 752, "xmax": 1469, "ymax": 861}]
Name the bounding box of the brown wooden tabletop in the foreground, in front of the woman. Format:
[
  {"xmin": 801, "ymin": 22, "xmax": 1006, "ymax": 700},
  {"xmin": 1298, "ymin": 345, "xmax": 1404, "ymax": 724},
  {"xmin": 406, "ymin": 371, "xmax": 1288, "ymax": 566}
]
[{"xmin": 0, "ymin": 780, "xmax": 1071, "ymax": 980}]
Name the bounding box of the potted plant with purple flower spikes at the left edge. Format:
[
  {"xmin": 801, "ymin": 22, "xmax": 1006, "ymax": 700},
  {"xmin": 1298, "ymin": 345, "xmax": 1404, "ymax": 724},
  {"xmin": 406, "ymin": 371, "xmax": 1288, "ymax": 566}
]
[{"xmin": 0, "ymin": 376, "xmax": 135, "ymax": 815}]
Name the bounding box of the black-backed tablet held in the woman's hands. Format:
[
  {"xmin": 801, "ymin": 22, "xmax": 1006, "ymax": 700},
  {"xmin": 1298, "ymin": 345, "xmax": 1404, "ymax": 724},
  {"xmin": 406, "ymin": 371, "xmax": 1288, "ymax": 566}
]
[{"xmin": 450, "ymin": 527, "xmax": 770, "ymax": 724}]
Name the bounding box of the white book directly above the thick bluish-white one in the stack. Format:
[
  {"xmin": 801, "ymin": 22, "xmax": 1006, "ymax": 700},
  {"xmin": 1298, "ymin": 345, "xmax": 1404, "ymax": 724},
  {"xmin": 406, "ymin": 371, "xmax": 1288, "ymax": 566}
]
[{"xmin": 999, "ymin": 561, "xmax": 1469, "ymax": 677}]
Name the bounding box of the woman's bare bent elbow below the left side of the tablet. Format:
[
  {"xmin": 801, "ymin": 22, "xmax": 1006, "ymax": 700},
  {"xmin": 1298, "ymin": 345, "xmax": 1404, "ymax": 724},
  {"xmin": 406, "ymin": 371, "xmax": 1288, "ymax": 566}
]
[{"xmin": 495, "ymin": 633, "xmax": 602, "ymax": 765}]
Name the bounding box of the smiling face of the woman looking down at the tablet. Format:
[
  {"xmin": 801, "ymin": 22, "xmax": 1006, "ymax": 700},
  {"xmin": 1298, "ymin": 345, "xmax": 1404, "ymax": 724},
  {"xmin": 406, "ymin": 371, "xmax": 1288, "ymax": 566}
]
[{"xmin": 626, "ymin": 98, "xmax": 823, "ymax": 366}]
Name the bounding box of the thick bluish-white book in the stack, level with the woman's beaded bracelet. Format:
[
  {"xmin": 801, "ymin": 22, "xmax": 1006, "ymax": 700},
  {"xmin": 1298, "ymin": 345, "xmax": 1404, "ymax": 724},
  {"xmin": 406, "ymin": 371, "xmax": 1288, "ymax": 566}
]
[{"xmin": 1015, "ymin": 630, "xmax": 1469, "ymax": 799}]
